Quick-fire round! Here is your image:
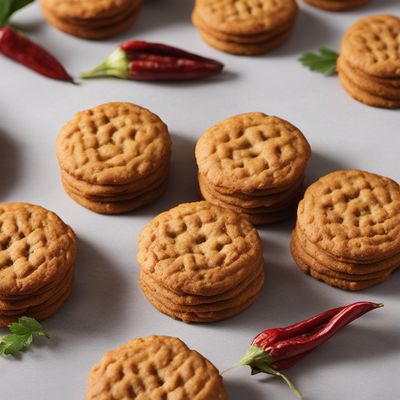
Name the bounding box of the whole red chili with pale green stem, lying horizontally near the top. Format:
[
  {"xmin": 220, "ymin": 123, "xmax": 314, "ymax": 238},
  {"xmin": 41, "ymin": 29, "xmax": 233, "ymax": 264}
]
[{"xmin": 81, "ymin": 40, "xmax": 224, "ymax": 81}]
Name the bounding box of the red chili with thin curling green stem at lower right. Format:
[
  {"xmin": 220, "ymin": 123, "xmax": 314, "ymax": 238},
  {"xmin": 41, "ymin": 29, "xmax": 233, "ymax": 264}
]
[{"xmin": 233, "ymin": 301, "xmax": 383, "ymax": 398}]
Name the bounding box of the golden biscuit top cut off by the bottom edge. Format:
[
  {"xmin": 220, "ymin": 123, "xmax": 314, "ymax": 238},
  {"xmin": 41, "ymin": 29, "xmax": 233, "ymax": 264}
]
[{"xmin": 85, "ymin": 336, "xmax": 227, "ymax": 400}]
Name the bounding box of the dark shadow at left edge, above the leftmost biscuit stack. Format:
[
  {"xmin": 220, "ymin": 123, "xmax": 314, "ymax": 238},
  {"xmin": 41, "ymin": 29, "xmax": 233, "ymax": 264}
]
[{"xmin": 0, "ymin": 128, "xmax": 21, "ymax": 202}]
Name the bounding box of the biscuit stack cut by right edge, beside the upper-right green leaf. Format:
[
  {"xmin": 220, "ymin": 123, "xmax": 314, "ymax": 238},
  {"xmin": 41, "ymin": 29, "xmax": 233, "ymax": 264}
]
[{"xmin": 337, "ymin": 15, "xmax": 400, "ymax": 108}]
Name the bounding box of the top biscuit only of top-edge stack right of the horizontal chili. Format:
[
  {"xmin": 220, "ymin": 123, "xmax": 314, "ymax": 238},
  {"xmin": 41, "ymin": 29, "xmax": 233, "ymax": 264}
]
[{"xmin": 195, "ymin": 0, "xmax": 298, "ymax": 35}]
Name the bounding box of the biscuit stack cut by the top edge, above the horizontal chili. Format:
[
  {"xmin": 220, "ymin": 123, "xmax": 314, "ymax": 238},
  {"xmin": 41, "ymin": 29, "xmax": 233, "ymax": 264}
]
[{"xmin": 41, "ymin": 0, "xmax": 142, "ymax": 39}]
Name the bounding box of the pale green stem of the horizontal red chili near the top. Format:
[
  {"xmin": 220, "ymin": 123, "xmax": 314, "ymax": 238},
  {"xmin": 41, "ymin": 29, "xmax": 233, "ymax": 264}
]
[{"xmin": 80, "ymin": 48, "xmax": 129, "ymax": 79}]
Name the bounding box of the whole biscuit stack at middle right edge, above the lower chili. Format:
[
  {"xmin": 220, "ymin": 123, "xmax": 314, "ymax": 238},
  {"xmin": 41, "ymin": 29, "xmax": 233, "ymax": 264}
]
[{"xmin": 291, "ymin": 170, "xmax": 400, "ymax": 290}]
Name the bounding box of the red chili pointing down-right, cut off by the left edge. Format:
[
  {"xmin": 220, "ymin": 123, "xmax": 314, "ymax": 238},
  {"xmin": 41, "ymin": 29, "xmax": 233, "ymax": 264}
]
[{"xmin": 0, "ymin": 27, "xmax": 72, "ymax": 82}]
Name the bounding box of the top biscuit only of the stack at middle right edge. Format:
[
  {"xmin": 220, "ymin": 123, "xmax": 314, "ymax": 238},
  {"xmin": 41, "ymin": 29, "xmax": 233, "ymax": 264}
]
[{"xmin": 298, "ymin": 170, "xmax": 400, "ymax": 262}]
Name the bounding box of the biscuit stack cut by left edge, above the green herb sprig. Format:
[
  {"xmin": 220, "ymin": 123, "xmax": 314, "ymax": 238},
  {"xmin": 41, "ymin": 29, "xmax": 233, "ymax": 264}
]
[{"xmin": 0, "ymin": 203, "xmax": 76, "ymax": 328}]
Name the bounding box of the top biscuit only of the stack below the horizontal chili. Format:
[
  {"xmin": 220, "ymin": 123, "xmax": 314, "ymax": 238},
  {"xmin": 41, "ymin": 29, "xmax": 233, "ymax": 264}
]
[{"xmin": 57, "ymin": 103, "xmax": 171, "ymax": 185}]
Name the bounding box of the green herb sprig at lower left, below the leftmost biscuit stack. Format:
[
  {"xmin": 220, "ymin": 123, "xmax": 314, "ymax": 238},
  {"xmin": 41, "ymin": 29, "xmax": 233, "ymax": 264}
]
[{"xmin": 0, "ymin": 317, "xmax": 49, "ymax": 356}]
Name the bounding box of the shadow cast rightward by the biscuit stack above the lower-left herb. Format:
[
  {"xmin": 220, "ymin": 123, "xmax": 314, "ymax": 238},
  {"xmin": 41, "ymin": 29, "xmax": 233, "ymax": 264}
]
[{"xmin": 46, "ymin": 238, "xmax": 130, "ymax": 336}]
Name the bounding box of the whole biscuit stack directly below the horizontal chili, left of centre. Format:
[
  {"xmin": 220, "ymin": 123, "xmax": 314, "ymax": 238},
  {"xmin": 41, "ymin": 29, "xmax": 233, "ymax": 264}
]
[{"xmin": 57, "ymin": 103, "xmax": 171, "ymax": 214}]
